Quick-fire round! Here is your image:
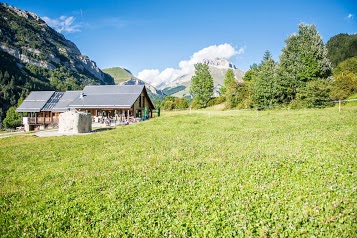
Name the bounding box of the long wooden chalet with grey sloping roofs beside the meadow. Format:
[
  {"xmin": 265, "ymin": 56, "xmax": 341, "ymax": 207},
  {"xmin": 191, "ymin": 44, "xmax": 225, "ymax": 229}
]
[{"xmin": 16, "ymin": 85, "xmax": 155, "ymax": 131}]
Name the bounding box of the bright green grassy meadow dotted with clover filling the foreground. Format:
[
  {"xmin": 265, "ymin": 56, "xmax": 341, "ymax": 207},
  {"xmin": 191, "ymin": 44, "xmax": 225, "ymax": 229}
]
[{"xmin": 0, "ymin": 107, "xmax": 357, "ymax": 237}]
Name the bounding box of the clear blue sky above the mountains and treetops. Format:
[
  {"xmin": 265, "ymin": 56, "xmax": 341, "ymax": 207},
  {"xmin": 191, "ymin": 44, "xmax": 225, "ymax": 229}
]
[{"xmin": 5, "ymin": 0, "xmax": 357, "ymax": 80}]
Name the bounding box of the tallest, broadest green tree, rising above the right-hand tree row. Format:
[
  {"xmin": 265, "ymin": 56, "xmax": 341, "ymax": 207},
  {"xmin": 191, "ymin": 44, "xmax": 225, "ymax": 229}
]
[{"xmin": 279, "ymin": 23, "xmax": 332, "ymax": 103}]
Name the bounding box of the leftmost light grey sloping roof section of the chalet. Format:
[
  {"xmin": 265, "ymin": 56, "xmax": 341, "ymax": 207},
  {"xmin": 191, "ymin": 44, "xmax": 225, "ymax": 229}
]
[{"xmin": 16, "ymin": 91, "xmax": 55, "ymax": 112}]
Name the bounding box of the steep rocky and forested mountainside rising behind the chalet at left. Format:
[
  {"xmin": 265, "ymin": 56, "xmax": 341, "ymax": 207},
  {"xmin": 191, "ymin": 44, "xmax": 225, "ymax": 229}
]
[{"xmin": 0, "ymin": 3, "xmax": 114, "ymax": 118}]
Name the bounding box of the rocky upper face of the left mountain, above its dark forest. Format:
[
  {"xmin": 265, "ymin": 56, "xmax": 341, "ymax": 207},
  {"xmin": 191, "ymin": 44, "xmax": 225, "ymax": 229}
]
[{"xmin": 0, "ymin": 4, "xmax": 114, "ymax": 84}]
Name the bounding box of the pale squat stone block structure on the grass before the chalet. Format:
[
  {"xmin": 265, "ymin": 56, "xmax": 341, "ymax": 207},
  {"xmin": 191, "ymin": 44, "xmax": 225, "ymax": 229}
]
[{"xmin": 58, "ymin": 111, "xmax": 92, "ymax": 133}]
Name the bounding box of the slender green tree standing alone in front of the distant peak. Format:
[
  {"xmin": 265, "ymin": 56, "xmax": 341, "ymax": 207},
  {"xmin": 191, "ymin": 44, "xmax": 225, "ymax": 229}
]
[{"xmin": 190, "ymin": 63, "xmax": 214, "ymax": 107}]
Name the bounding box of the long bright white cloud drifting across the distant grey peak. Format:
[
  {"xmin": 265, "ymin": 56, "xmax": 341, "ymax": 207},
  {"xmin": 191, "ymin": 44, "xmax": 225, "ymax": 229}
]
[{"xmin": 137, "ymin": 43, "xmax": 245, "ymax": 86}]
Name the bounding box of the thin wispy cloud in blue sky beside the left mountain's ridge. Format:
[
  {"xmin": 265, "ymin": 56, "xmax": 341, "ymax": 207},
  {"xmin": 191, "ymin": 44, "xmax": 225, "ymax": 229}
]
[{"xmin": 42, "ymin": 16, "xmax": 81, "ymax": 33}]
